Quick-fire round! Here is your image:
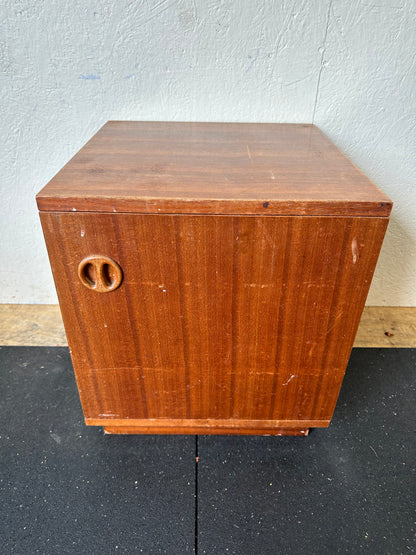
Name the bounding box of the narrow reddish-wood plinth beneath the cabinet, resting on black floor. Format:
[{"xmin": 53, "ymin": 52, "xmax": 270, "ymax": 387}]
[{"xmin": 104, "ymin": 426, "xmax": 309, "ymax": 436}]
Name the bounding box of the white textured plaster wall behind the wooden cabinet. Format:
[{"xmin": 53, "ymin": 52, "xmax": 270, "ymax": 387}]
[{"xmin": 0, "ymin": 0, "xmax": 416, "ymax": 305}]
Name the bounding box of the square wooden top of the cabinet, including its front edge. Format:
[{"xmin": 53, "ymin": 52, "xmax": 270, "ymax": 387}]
[{"xmin": 37, "ymin": 121, "xmax": 392, "ymax": 216}]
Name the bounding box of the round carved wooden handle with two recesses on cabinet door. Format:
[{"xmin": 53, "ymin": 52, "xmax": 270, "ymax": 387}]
[{"xmin": 78, "ymin": 254, "xmax": 123, "ymax": 293}]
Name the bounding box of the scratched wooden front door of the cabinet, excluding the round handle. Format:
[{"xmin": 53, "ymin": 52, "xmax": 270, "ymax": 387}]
[{"xmin": 41, "ymin": 213, "xmax": 387, "ymax": 425}]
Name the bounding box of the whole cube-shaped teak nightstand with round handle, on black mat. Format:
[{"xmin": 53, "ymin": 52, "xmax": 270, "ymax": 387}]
[{"xmin": 37, "ymin": 122, "xmax": 392, "ymax": 435}]
